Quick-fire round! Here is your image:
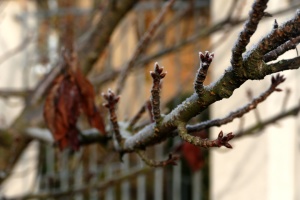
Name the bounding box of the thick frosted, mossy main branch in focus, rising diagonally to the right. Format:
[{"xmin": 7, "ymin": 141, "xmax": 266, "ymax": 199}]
[{"xmin": 119, "ymin": 11, "xmax": 300, "ymax": 151}]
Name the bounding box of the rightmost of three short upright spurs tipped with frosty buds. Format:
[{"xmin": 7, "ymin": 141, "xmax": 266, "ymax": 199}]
[{"xmin": 194, "ymin": 51, "xmax": 214, "ymax": 95}]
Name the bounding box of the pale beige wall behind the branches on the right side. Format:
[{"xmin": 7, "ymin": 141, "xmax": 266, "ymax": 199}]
[{"xmin": 211, "ymin": 0, "xmax": 300, "ymax": 200}]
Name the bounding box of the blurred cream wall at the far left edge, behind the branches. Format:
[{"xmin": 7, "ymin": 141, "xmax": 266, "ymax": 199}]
[{"xmin": 0, "ymin": 0, "xmax": 38, "ymax": 198}]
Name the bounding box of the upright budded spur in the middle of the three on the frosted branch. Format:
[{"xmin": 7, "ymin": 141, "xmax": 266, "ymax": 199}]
[{"xmin": 150, "ymin": 63, "xmax": 167, "ymax": 123}]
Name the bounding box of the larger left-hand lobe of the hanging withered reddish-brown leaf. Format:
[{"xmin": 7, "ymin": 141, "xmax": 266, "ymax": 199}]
[{"xmin": 44, "ymin": 76, "xmax": 80, "ymax": 150}]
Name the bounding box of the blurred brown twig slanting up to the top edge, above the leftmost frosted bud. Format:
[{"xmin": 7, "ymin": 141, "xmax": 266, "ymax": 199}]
[{"xmin": 116, "ymin": 0, "xmax": 175, "ymax": 94}]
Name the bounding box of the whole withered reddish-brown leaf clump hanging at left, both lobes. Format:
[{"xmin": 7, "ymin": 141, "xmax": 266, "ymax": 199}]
[{"xmin": 44, "ymin": 63, "xmax": 105, "ymax": 150}]
